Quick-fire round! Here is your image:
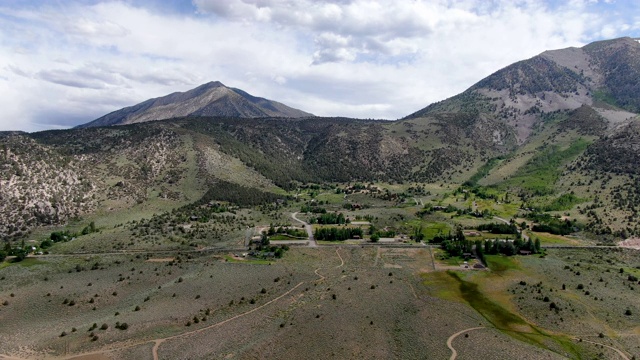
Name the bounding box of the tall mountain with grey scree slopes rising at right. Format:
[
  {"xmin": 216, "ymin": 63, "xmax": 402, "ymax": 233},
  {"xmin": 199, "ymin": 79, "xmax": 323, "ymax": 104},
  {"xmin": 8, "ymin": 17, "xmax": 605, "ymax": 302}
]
[{"xmin": 405, "ymin": 37, "xmax": 640, "ymax": 144}]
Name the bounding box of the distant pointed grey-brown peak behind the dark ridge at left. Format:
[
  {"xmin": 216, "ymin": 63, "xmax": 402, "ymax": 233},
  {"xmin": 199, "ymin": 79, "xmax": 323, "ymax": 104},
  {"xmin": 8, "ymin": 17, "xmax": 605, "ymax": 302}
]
[{"xmin": 78, "ymin": 81, "xmax": 313, "ymax": 128}]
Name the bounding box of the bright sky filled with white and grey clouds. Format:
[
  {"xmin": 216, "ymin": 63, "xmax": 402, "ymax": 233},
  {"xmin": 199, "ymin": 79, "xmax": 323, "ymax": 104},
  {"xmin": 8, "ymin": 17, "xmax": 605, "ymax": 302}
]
[{"xmin": 0, "ymin": 0, "xmax": 640, "ymax": 131}]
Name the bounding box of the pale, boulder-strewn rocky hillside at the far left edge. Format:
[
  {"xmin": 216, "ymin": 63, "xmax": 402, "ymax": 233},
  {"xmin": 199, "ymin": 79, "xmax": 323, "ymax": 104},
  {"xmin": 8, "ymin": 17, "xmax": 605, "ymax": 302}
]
[{"xmin": 0, "ymin": 135, "xmax": 96, "ymax": 238}]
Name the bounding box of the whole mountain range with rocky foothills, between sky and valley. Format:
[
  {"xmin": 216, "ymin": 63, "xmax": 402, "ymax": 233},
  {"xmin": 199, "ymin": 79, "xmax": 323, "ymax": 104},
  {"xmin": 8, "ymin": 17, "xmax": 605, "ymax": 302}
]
[{"xmin": 0, "ymin": 38, "xmax": 640, "ymax": 238}]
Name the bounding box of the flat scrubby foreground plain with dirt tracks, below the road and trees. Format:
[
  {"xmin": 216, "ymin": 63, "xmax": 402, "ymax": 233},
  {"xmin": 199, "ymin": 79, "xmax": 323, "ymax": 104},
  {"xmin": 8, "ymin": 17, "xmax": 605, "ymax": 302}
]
[{"xmin": 0, "ymin": 245, "xmax": 640, "ymax": 359}]
